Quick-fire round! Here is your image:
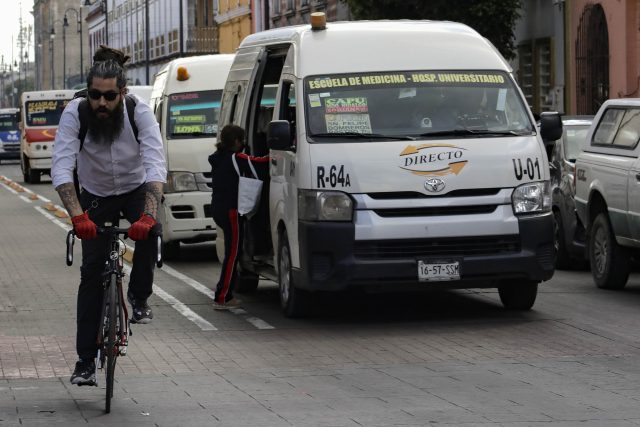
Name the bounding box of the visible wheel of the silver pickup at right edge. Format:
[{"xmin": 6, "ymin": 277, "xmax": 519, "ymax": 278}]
[{"xmin": 589, "ymin": 212, "xmax": 630, "ymax": 289}]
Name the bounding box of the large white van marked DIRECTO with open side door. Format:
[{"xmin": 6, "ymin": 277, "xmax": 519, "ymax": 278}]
[{"xmin": 220, "ymin": 17, "xmax": 562, "ymax": 316}]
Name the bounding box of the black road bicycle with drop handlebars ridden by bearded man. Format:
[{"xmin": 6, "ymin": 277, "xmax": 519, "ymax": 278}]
[{"xmin": 66, "ymin": 224, "xmax": 162, "ymax": 413}]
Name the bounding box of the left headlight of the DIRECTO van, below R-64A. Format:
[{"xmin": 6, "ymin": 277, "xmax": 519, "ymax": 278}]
[{"xmin": 298, "ymin": 190, "xmax": 353, "ymax": 221}]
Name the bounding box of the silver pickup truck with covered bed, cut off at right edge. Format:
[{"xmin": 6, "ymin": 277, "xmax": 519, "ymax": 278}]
[{"xmin": 574, "ymin": 99, "xmax": 640, "ymax": 289}]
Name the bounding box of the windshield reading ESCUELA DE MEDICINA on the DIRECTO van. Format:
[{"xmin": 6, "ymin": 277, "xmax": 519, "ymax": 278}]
[{"xmin": 304, "ymin": 71, "xmax": 534, "ymax": 142}]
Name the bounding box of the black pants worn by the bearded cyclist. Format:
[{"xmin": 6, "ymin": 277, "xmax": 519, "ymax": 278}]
[{"xmin": 76, "ymin": 186, "xmax": 156, "ymax": 360}]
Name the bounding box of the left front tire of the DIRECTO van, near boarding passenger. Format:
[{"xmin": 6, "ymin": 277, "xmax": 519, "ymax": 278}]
[{"xmin": 278, "ymin": 231, "xmax": 310, "ymax": 318}]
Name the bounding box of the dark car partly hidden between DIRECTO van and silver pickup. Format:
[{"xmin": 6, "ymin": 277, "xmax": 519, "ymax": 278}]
[{"xmin": 549, "ymin": 116, "xmax": 593, "ymax": 269}]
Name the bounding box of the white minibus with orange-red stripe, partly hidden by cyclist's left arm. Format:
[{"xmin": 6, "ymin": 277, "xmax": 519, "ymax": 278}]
[{"xmin": 20, "ymin": 89, "xmax": 76, "ymax": 183}]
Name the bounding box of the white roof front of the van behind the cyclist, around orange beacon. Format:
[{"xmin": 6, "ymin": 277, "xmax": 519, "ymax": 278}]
[{"xmin": 152, "ymin": 54, "xmax": 235, "ymax": 97}]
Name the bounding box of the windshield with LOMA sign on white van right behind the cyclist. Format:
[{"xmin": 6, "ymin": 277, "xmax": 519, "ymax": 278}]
[{"xmin": 167, "ymin": 90, "xmax": 222, "ymax": 139}]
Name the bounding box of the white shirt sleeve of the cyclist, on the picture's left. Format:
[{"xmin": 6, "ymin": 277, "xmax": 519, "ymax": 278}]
[{"xmin": 51, "ymin": 100, "xmax": 80, "ymax": 188}]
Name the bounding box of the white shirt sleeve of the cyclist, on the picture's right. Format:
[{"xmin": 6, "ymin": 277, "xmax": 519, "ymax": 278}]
[{"xmin": 135, "ymin": 98, "xmax": 167, "ymax": 183}]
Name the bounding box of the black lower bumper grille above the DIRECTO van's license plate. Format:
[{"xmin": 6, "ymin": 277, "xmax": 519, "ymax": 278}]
[{"xmin": 354, "ymin": 235, "xmax": 520, "ymax": 259}]
